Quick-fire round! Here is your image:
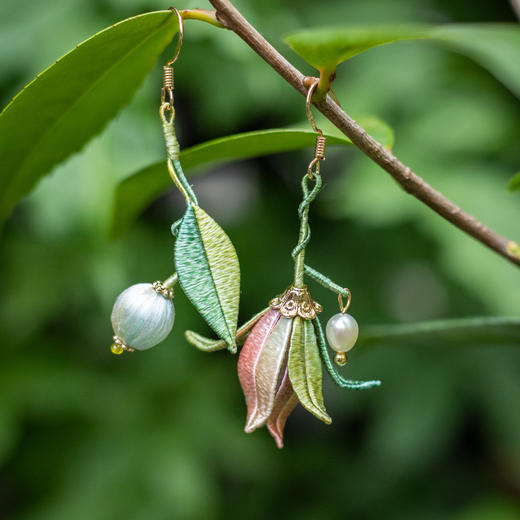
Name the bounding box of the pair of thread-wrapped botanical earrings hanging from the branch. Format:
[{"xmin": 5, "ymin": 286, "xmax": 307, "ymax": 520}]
[{"xmin": 111, "ymin": 10, "xmax": 380, "ymax": 448}]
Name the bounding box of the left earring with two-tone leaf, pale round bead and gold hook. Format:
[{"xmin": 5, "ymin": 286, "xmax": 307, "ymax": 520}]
[{"xmin": 110, "ymin": 19, "xmax": 243, "ymax": 362}]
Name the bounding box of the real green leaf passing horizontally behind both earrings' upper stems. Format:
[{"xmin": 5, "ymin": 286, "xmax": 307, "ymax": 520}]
[{"xmin": 111, "ymin": 117, "xmax": 393, "ymax": 236}]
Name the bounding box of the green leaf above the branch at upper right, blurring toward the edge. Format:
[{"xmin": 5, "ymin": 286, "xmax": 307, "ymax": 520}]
[{"xmin": 285, "ymin": 24, "xmax": 520, "ymax": 97}]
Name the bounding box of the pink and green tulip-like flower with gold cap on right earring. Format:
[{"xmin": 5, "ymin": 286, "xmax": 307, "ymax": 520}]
[{"xmin": 238, "ymin": 286, "xmax": 379, "ymax": 448}]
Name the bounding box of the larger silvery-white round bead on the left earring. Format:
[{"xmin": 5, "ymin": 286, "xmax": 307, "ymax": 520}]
[{"xmin": 111, "ymin": 283, "xmax": 175, "ymax": 350}]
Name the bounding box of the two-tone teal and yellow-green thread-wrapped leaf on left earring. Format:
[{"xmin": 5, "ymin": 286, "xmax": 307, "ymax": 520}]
[{"xmin": 175, "ymin": 203, "xmax": 240, "ymax": 353}]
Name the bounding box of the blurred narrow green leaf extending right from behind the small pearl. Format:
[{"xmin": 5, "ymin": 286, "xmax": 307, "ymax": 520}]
[{"xmin": 359, "ymin": 317, "xmax": 520, "ymax": 346}]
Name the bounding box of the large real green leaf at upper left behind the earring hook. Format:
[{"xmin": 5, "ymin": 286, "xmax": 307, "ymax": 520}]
[{"xmin": 0, "ymin": 11, "xmax": 177, "ymax": 221}]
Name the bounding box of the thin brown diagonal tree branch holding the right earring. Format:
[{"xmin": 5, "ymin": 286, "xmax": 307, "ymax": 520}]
[{"xmin": 209, "ymin": 0, "xmax": 520, "ymax": 265}]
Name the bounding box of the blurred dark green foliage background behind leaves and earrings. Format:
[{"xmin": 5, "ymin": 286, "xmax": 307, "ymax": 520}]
[{"xmin": 0, "ymin": 0, "xmax": 520, "ymax": 520}]
